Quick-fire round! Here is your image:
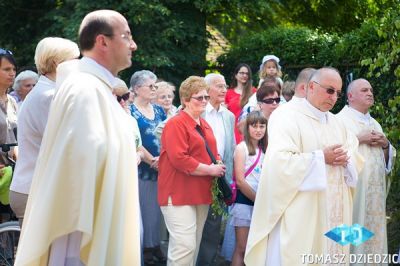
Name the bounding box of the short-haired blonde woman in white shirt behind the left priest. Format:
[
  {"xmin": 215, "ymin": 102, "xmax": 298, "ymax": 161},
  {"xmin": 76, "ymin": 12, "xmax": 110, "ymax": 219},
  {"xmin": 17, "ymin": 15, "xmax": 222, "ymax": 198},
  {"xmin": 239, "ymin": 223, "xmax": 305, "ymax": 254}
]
[{"xmin": 10, "ymin": 37, "xmax": 79, "ymax": 224}]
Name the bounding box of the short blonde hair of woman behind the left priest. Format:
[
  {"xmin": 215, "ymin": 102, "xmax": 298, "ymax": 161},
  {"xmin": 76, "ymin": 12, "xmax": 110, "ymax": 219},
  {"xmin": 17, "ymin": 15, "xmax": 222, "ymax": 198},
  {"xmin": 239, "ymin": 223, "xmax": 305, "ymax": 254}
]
[{"xmin": 35, "ymin": 37, "xmax": 80, "ymax": 75}]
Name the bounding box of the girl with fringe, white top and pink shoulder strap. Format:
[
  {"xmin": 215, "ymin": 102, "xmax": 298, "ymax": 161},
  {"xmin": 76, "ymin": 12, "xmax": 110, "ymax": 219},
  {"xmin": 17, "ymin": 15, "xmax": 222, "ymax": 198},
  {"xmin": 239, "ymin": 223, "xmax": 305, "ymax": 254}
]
[{"xmin": 231, "ymin": 111, "xmax": 267, "ymax": 266}]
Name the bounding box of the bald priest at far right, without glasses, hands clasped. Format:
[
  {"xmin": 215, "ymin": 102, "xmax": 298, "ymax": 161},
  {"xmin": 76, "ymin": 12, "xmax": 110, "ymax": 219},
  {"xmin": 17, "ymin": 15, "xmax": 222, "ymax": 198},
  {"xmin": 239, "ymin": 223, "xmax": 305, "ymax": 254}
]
[{"xmin": 337, "ymin": 79, "xmax": 395, "ymax": 265}]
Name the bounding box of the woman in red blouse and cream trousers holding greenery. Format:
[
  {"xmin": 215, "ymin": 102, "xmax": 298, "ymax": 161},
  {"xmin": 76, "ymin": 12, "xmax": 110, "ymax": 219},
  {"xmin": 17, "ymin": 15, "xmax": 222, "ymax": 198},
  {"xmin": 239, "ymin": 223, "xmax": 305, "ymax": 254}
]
[{"xmin": 158, "ymin": 76, "xmax": 225, "ymax": 265}]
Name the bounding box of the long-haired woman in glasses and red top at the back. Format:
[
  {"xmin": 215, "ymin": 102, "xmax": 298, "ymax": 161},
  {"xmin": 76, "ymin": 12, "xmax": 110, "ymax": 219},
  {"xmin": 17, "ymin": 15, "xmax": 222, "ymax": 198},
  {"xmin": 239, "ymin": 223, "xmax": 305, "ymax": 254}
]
[{"xmin": 225, "ymin": 63, "xmax": 256, "ymax": 143}]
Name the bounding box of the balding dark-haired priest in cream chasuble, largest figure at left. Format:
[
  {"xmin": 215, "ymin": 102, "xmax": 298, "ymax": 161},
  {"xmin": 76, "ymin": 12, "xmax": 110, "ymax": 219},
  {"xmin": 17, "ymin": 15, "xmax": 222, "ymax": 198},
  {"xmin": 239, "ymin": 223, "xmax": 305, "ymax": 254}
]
[{"xmin": 15, "ymin": 10, "xmax": 141, "ymax": 266}]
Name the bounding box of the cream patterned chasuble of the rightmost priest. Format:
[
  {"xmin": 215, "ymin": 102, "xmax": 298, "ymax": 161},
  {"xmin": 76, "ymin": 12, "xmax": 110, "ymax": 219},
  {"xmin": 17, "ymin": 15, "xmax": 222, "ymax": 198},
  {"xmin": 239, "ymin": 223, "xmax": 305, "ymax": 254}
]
[{"xmin": 337, "ymin": 106, "xmax": 394, "ymax": 264}]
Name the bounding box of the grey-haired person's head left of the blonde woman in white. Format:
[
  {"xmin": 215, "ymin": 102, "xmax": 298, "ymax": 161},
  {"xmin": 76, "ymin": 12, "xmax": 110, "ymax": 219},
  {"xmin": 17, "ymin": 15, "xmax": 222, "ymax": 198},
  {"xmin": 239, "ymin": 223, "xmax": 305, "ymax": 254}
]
[{"xmin": 11, "ymin": 70, "xmax": 39, "ymax": 106}]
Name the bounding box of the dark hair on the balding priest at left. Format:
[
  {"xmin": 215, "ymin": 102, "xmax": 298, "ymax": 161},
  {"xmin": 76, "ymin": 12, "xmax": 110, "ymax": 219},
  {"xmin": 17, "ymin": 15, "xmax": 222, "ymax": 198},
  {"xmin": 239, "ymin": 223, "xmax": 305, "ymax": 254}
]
[{"xmin": 79, "ymin": 17, "xmax": 114, "ymax": 51}]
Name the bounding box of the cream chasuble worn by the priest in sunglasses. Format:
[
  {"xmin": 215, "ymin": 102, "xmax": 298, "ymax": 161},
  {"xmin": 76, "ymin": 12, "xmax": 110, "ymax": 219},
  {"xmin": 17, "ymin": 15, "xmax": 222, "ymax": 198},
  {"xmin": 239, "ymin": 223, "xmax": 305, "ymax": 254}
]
[{"xmin": 245, "ymin": 100, "xmax": 363, "ymax": 266}]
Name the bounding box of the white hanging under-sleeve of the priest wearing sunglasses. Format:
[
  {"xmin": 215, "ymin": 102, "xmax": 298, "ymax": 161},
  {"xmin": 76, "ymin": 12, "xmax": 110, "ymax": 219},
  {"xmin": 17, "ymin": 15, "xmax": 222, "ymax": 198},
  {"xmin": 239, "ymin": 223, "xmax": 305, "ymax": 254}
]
[{"xmin": 299, "ymin": 150, "xmax": 328, "ymax": 191}]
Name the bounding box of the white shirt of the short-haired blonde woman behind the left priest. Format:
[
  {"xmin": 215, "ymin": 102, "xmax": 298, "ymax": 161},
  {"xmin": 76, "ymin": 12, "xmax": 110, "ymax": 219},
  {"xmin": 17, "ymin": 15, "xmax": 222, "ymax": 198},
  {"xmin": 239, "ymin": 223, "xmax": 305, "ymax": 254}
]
[{"xmin": 10, "ymin": 76, "xmax": 55, "ymax": 194}]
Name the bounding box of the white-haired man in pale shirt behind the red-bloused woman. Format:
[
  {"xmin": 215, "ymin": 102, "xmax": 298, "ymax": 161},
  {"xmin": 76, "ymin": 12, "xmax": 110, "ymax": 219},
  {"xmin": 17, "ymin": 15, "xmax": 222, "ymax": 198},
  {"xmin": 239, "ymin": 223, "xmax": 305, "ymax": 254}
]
[{"xmin": 197, "ymin": 73, "xmax": 235, "ymax": 266}]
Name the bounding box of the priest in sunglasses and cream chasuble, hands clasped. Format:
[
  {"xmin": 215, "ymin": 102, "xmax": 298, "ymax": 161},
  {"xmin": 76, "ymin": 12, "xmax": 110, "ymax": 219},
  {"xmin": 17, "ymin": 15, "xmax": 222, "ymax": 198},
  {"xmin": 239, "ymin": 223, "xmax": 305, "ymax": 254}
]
[{"xmin": 245, "ymin": 67, "xmax": 363, "ymax": 266}]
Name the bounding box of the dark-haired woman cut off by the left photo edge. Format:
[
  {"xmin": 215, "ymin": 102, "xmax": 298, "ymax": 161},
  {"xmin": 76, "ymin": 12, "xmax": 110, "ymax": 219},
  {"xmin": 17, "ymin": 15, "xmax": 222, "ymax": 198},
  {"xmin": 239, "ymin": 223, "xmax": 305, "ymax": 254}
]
[{"xmin": 0, "ymin": 48, "xmax": 18, "ymax": 168}]
